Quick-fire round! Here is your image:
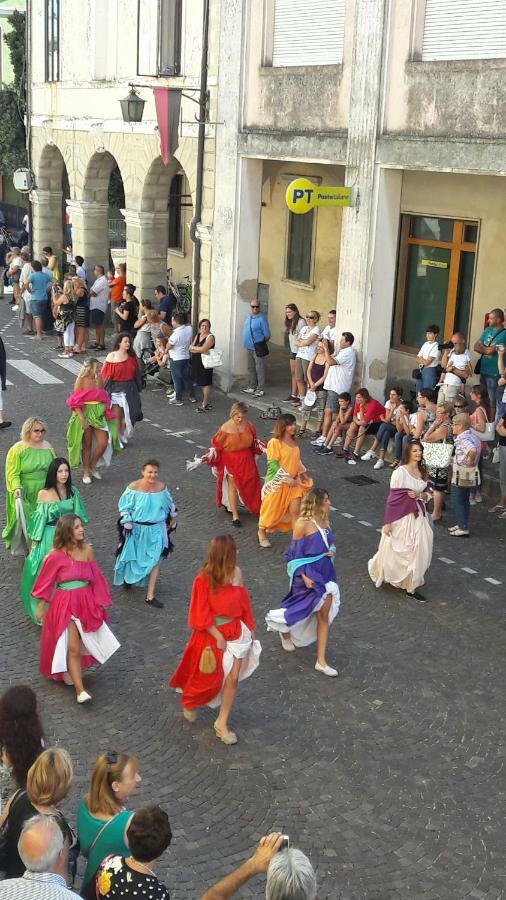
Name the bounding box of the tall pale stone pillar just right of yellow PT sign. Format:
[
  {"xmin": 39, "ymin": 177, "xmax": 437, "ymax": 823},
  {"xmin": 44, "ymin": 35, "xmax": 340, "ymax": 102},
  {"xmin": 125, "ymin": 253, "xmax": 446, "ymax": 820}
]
[{"xmin": 337, "ymin": 0, "xmax": 388, "ymax": 394}]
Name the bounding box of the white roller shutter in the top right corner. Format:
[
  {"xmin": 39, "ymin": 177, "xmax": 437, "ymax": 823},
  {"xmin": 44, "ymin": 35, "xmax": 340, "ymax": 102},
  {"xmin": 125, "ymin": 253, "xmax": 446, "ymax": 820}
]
[{"xmin": 422, "ymin": 0, "xmax": 506, "ymax": 60}]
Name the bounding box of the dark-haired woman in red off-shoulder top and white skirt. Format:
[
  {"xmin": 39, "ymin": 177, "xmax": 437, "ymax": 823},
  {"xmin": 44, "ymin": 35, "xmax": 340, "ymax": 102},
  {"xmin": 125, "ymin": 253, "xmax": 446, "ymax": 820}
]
[{"xmin": 100, "ymin": 332, "xmax": 142, "ymax": 445}]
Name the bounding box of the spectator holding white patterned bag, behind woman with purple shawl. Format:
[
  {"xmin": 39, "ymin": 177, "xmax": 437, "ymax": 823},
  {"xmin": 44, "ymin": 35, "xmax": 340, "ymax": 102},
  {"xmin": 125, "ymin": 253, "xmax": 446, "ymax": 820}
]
[{"xmin": 422, "ymin": 400, "xmax": 453, "ymax": 522}]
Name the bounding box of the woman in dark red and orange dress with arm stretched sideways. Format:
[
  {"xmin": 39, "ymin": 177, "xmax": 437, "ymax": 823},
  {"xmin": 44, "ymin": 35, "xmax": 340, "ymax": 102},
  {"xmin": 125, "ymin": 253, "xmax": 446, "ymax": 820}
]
[{"xmin": 187, "ymin": 403, "xmax": 265, "ymax": 528}]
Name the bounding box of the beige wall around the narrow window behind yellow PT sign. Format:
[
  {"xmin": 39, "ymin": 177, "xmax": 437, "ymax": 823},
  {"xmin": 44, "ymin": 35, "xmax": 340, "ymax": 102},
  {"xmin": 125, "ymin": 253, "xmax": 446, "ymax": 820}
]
[{"xmin": 259, "ymin": 162, "xmax": 344, "ymax": 343}]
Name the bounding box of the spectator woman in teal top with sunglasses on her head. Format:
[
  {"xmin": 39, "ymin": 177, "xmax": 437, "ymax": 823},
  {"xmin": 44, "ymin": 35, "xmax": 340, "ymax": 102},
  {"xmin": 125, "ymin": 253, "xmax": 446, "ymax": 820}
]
[{"xmin": 77, "ymin": 751, "xmax": 141, "ymax": 898}]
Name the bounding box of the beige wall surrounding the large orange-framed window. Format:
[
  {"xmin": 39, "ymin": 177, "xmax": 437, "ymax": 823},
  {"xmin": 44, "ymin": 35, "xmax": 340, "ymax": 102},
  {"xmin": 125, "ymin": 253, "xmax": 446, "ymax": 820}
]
[{"xmin": 389, "ymin": 172, "xmax": 506, "ymax": 377}]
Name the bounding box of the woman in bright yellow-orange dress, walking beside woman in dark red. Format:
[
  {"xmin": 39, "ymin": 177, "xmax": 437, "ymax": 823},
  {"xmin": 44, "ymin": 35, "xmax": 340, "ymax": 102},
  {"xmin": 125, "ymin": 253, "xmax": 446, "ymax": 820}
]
[{"xmin": 258, "ymin": 413, "xmax": 313, "ymax": 548}]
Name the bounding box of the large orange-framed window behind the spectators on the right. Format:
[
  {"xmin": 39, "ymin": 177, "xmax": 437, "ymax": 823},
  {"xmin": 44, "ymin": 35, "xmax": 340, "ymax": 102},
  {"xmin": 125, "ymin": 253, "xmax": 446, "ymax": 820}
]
[{"xmin": 392, "ymin": 215, "xmax": 478, "ymax": 351}]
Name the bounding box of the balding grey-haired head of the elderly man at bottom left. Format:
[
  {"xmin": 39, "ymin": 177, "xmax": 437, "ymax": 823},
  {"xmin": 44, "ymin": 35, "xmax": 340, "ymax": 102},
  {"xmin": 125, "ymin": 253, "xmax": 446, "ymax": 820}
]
[{"xmin": 18, "ymin": 815, "xmax": 68, "ymax": 873}]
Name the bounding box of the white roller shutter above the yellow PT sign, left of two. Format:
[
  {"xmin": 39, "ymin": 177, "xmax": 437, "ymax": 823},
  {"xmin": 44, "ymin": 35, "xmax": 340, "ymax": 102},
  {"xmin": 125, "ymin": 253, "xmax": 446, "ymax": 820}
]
[{"xmin": 272, "ymin": 0, "xmax": 345, "ymax": 66}]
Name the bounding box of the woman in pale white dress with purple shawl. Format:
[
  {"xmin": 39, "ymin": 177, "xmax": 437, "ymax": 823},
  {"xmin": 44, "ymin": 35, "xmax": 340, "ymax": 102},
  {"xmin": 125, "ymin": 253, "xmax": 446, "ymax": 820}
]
[{"xmin": 368, "ymin": 439, "xmax": 433, "ymax": 602}]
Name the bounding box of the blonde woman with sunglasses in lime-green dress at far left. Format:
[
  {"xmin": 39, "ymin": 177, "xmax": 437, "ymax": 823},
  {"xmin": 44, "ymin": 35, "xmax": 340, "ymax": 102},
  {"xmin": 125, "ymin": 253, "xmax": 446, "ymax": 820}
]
[{"xmin": 2, "ymin": 416, "xmax": 56, "ymax": 552}]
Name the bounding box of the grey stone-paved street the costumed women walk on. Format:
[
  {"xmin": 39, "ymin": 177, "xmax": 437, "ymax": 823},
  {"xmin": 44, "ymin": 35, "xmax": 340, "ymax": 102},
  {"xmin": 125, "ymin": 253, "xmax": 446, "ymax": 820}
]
[{"xmin": 0, "ymin": 309, "xmax": 506, "ymax": 900}]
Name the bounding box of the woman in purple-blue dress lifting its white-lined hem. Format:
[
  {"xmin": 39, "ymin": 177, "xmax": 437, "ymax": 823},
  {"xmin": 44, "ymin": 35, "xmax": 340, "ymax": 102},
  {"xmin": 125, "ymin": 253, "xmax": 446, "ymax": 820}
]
[{"xmin": 265, "ymin": 488, "xmax": 340, "ymax": 677}]
